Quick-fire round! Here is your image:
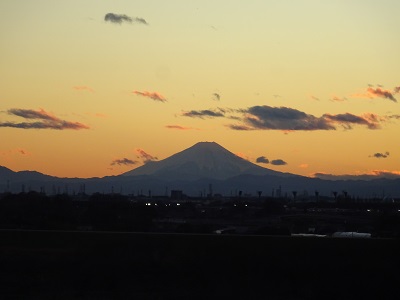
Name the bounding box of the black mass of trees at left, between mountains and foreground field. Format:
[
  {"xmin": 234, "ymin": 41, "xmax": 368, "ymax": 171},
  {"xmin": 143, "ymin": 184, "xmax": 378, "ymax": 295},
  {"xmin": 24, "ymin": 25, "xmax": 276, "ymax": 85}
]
[{"xmin": 0, "ymin": 192, "xmax": 156, "ymax": 231}]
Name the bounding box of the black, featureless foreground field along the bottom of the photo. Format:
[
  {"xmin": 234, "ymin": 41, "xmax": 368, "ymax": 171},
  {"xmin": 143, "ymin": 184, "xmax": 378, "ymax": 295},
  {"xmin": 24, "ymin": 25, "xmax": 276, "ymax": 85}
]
[{"xmin": 0, "ymin": 231, "xmax": 400, "ymax": 299}]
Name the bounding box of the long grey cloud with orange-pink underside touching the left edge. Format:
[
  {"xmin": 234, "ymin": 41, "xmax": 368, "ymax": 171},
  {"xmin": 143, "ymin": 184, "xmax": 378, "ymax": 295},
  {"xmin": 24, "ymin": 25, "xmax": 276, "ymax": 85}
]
[{"xmin": 0, "ymin": 108, "xmax": 90, "ymax": 130}]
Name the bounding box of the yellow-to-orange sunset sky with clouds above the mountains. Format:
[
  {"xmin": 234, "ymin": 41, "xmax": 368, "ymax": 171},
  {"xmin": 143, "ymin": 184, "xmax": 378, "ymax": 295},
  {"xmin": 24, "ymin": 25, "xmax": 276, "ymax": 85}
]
[{"xmin": 0, "ymin": 0, "xmax": 400, "ymax": 177}]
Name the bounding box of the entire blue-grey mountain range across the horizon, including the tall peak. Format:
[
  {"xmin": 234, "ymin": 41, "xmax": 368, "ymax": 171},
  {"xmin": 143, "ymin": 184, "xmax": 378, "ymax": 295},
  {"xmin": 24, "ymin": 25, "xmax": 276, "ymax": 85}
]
[{"xmin": 0, "ymin": 142, "xmax": 400, "ymax": 198}]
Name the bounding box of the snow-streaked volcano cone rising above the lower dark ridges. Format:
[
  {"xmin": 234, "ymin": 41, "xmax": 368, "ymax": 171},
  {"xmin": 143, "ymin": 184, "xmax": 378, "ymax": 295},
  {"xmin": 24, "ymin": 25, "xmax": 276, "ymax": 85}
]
[{"xmin": 123, "ymin": 142, "xmax": 281, "ymax": 180}]
